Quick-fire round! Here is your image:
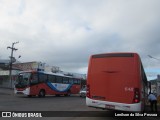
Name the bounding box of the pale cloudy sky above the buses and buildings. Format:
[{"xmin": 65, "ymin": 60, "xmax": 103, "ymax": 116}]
[{"xmin": 0, "ymin": 0, "xmax": 160, "ymax": 79}]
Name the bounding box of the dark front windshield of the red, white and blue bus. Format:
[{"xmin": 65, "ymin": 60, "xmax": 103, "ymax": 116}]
[{"xmin": 17, "ymin": 73, "xmax": 31, "ymax": 86}]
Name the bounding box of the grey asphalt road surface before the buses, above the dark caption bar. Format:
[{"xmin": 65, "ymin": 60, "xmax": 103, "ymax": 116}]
[{"xmin": 0, "ymin": 89, "xmax": 96, "ymax": 111}]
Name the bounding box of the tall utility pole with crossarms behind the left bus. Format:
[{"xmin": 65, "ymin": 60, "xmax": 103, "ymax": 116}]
[{"xmin": 7, "ymin": 42, "xmax": 19, "ymax": 88}]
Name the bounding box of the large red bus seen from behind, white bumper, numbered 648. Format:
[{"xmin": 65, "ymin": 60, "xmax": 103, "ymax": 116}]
[{"xmin": 86, "ymin": 53, "xmax": 148, "ymax": 111}]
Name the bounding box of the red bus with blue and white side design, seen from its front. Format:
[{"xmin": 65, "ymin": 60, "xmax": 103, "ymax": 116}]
[{"xmin": 14, "ymin": 71, "xmax": 81, "ymax": 97}]
